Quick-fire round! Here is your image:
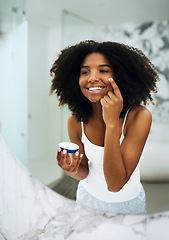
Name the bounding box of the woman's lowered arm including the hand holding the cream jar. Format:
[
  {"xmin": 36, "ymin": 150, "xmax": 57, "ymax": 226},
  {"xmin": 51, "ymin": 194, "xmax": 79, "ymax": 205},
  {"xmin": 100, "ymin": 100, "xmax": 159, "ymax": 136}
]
[{"xmin": 57, "ymin": 115, "xmax": 89, "ymax": 180}]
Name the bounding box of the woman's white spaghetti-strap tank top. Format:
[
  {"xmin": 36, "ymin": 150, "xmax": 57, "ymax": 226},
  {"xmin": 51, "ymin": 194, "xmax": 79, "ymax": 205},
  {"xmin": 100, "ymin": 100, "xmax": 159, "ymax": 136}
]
[{"xmin": 81, "ymin": 111, "xmax": 142, "ymax": 202}]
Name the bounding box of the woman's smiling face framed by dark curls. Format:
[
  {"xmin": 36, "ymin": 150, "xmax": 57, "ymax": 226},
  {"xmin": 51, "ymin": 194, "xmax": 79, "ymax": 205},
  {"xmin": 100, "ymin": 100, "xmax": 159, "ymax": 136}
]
[{"xmin": 79, "ymin": 53, "xmax": 113, "ymax": 103}]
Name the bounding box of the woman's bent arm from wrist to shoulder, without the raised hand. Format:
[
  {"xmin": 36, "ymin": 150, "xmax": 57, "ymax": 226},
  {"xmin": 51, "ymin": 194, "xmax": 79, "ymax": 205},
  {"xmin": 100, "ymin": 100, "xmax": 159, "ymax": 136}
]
[{"xmin": 103, "ymin": 107, "xmax": 152, "ymax": 192}]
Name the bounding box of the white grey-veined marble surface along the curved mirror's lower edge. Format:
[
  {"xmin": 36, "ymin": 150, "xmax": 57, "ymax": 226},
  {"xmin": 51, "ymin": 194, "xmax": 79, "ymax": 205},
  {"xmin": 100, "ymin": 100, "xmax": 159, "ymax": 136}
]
[{"xmin": 0, "ymin": 136, "xmax": 169, "ymax": 240}]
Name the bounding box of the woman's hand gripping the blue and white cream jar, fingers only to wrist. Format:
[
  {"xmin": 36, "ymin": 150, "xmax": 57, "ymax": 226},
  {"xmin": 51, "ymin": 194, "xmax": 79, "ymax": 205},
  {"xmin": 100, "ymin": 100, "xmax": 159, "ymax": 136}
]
[{"xmin": 57, "ymin": 148, "xmax": 83, "ymax": 174}]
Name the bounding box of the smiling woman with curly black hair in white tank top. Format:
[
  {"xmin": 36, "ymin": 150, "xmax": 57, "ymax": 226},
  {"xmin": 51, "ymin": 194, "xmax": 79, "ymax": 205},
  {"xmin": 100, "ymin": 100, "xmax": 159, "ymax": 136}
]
[{"xmin": 51, "ymin": 41, "xmax": 158, "ymax": 214}]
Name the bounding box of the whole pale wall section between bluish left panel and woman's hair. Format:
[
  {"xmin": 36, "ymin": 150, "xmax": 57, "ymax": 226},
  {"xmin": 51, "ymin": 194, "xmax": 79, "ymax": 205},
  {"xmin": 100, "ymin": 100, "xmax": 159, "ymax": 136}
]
[{"xmin": 28, "ymin": 9, "xmax": 62, "ymax": 185}]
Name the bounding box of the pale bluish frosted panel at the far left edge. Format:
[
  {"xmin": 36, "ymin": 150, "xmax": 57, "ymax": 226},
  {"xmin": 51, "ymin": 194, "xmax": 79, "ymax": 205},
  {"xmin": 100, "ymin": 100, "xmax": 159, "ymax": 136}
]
[{"xmin": 0, "ymin": 21, "xmax": 27, "ymax": 166}]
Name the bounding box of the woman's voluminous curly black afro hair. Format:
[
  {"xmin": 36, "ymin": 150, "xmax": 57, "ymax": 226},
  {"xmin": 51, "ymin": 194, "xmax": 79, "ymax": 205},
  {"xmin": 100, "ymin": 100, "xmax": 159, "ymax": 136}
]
[{"xmin": 50, "ymin": 40, "xmax": 159, "ymax": 123}]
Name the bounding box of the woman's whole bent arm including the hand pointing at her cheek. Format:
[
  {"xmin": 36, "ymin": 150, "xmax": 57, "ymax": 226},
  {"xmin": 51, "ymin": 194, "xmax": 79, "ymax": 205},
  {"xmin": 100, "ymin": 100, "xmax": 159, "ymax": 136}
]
[{"xmin": 101, "ymin": 79, "xmax": 152, "ymax": 192}]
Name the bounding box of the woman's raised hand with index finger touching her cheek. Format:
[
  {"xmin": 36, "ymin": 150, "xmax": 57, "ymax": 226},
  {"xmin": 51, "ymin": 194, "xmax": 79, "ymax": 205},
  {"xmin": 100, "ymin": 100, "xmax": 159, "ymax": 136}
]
[{"xmin": 100, "ymin": 78, "xmax": 123, "ymax": 125}]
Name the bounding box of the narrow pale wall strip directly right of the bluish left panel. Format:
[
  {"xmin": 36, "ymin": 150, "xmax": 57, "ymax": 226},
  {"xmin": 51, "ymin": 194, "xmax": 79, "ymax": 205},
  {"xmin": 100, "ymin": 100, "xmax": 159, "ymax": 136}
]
[{"xmin": 28, "ymin": 22, "xmax": 48, "ymax": 159}]
